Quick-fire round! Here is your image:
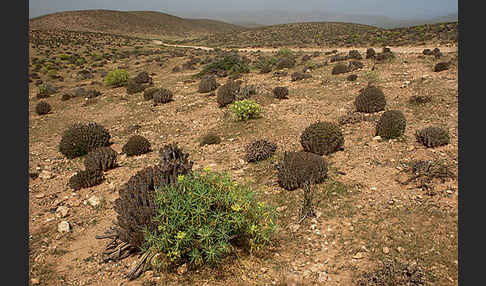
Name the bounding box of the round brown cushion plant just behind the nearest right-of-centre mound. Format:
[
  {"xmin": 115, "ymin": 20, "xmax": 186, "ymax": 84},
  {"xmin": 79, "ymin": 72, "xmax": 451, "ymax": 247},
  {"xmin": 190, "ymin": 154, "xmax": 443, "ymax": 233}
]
[{"xmin": 300, "ymin": 121, "xmax": 344, "ymax": 155}]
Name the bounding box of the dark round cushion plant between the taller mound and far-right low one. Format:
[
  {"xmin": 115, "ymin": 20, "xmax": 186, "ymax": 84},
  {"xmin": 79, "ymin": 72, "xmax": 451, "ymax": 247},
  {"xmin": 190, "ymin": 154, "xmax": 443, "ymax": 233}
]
[{"xmin": 375, "ymin": 110, "xmax": 407, "ymax": 139}]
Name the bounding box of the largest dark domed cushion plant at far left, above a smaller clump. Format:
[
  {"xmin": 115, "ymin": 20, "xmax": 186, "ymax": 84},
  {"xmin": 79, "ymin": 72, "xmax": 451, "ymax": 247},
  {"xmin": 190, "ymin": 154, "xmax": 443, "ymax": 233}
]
[{"xmin": 59, "ymin": 122, "xmax": 111, "ymax": 159}]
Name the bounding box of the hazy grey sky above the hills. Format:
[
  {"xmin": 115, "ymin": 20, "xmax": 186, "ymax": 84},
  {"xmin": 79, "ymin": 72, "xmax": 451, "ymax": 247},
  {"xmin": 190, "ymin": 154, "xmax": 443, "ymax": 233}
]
[{"xmin": 29, "ymin": 0, "xmax": 458, "ymax": 19}]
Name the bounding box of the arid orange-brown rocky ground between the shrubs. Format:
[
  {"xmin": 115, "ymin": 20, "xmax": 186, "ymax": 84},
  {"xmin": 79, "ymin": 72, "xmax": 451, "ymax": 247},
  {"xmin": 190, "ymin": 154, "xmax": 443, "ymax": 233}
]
[{"xmin": 29, "ymin": 27, "xmax": 458, "ymax": 286}]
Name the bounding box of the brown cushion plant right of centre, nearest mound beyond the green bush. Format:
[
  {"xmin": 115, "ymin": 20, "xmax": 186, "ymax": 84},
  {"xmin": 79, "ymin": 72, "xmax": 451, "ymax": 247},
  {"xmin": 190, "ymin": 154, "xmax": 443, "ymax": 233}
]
[{"xmin": 276, "ymin": 151, "xmax": 328, "ymax": 191}]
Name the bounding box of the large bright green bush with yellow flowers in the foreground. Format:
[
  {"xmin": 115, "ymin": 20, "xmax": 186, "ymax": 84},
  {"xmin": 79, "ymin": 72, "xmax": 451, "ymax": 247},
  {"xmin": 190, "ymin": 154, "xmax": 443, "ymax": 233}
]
[{"xmin": 144, "ymin": 171, "xmax": 276, "ymax": 267}]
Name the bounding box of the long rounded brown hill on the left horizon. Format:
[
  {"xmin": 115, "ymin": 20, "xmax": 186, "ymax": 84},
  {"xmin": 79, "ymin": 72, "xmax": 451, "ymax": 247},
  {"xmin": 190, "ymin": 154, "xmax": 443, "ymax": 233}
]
[{"xmin": 29, "ymin": 10, "xmax": 244, "ymax": 37}]
